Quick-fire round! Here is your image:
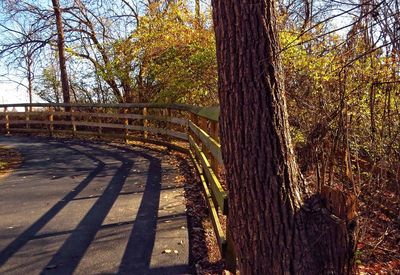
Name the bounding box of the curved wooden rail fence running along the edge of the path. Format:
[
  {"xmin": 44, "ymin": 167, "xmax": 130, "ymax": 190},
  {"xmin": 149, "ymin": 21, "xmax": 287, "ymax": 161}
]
[{"xmin": 0, "ymin": 103, "xmax": 236, "ymax": 271}]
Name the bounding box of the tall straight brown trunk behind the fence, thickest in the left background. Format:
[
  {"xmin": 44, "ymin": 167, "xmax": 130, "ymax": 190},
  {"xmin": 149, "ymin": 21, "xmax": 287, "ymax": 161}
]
[{"xmin": 52, "ymin": 0, "xmax": 71, "ymax": 103}]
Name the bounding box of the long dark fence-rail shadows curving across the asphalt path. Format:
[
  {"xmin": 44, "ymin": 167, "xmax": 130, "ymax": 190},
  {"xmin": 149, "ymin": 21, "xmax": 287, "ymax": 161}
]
[{"xmin": 0, "ymin": 137, "xmax": 190, "ymax": 274}]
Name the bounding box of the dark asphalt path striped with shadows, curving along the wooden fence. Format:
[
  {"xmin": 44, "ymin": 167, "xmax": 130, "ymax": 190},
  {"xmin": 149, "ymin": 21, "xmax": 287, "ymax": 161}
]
[{"xmin": 0, "ymin": 136, "xmax": 191, "ymax": 275}]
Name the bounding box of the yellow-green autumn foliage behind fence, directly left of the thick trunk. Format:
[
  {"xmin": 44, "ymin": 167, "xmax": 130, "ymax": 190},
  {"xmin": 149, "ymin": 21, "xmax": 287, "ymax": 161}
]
[{"xmin": 119, "ymin": 1, "xmax": 217, "ymax": 104}]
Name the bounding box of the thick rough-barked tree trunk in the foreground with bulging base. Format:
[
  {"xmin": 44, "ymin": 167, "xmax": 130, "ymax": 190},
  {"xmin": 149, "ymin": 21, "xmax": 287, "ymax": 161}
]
[{"xmin": 213, "ymin": 0, "xmax": 355, "ymax": 274}]
